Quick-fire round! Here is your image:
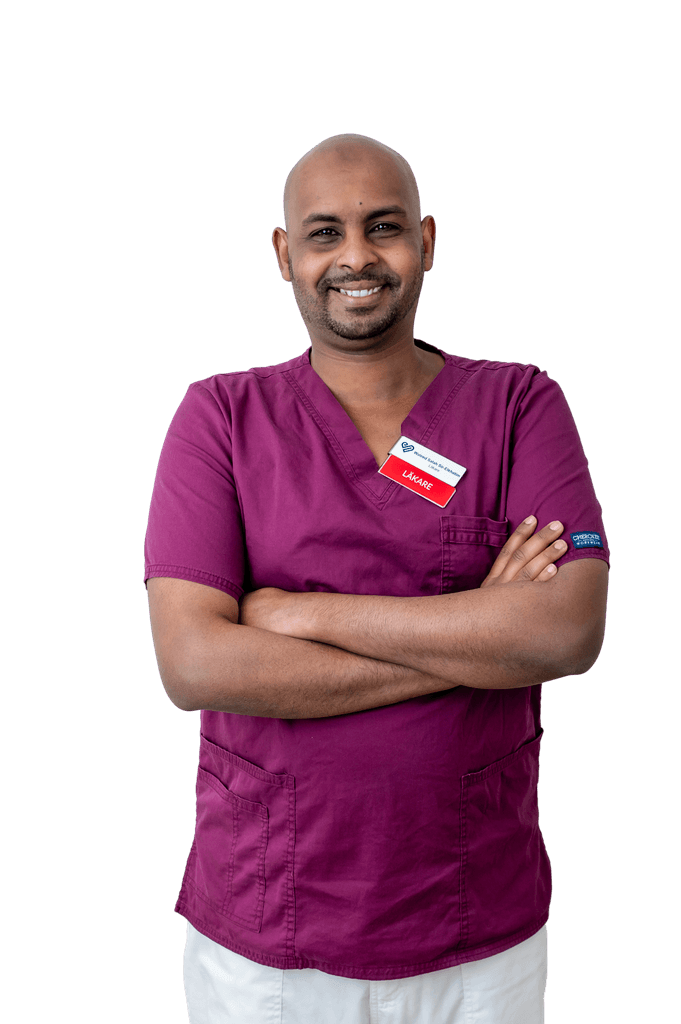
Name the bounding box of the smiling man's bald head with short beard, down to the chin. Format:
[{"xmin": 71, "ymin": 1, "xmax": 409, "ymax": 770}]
[{"xmin": 272, "ymin": 138, "xmax": 435, "ymax": 351}]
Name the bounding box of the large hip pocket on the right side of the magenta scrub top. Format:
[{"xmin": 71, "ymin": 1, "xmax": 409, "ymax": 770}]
[{"xmin": 461, "ymin": 732, "xmax": 551, "ymax": 946}]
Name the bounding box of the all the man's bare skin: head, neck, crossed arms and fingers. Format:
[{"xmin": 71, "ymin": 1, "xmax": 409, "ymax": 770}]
[{"xmin": 147, "ymin": 136, "xmax": 607, "ymax": 719}]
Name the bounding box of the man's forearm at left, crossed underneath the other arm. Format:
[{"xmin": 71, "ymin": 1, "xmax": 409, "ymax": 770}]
[{"xmin": 160, "ymin": 616, "xmax": 452, "ymax": 719}]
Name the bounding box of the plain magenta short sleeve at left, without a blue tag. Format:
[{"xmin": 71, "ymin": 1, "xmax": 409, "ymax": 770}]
[{"xmin": 144, "ymin": 382, "xmax": 246, "ymax": 601}]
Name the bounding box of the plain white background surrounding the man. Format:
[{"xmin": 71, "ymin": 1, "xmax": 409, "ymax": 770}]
[{"xmin": 0, "ymin": 0, "xmax": 680, "ymax": 1024}]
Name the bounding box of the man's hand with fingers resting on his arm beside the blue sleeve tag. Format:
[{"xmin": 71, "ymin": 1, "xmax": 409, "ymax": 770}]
[{"xmin": 480, "ymin": 515, "xmax": 567, "ymax": 588}]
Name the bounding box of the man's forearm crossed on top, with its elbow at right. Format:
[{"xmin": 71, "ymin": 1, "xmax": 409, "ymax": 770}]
[{"xmin": 262, "ymin": 566, "xmax": 602, "ymax": 689}]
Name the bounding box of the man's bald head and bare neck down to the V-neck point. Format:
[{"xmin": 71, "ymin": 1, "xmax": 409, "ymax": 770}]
[{"xmin": 272, "ymin": 136, "xmax": 444, "ymax": 465}]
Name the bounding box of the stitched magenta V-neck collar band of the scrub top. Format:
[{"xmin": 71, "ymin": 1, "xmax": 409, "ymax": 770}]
[{"xmin": 285, "ymin": 340, "xmax": 468, "ymax": 508}]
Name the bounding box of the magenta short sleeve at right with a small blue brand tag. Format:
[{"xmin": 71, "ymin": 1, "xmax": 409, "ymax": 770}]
[{"xmin": 506, "ymin": 371, "xmax": 610, "ymax": 565}]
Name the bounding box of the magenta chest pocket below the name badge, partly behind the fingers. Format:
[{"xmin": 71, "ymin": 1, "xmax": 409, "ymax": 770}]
[{"xmin": 440, "ymin": 515, "xmax": 509, "ymax": 594}]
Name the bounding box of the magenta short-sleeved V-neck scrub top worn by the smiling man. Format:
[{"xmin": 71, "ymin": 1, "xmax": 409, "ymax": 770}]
[{"xmin": 144, "ymin": 342, "xmax": 609, "ymax": 980}]
